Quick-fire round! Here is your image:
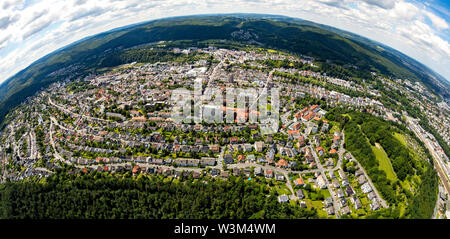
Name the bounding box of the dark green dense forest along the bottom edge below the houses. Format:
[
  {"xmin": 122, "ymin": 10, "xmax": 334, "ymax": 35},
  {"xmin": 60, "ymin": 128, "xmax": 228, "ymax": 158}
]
[{"xmin": 0, "ymin": 171, "xmax": 318, "ymax": 219}]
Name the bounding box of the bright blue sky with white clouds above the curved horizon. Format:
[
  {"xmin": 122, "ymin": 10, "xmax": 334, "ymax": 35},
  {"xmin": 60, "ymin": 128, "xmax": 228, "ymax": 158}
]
[{"xmin": 0, "ymin": 0, "xmax": 450, "ymax": 83}]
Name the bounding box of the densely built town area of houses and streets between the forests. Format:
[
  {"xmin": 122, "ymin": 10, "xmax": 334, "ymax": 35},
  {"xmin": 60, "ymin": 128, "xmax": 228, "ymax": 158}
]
[{"xmin": 0, "ymin": 47, "xmax": 450, "ymax": 218}]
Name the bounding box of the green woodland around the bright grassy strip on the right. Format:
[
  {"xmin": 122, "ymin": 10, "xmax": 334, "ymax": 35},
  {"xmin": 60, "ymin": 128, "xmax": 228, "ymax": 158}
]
[{"xmin": 327, "ymin": 108, "xmax": 438, "ymax": 218}]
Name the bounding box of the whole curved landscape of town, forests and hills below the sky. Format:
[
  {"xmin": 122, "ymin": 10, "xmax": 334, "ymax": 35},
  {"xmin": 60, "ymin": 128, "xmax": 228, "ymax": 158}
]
[{"xmin": 0, "ymin": 0, "xmax": 450, "ymax": 225}]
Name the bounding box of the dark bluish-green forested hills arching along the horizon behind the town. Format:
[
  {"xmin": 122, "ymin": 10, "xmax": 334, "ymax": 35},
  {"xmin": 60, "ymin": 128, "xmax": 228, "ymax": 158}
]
[{"xmin": 0, "ymin": 14, "xmax": 449, "ymax": 126}]
